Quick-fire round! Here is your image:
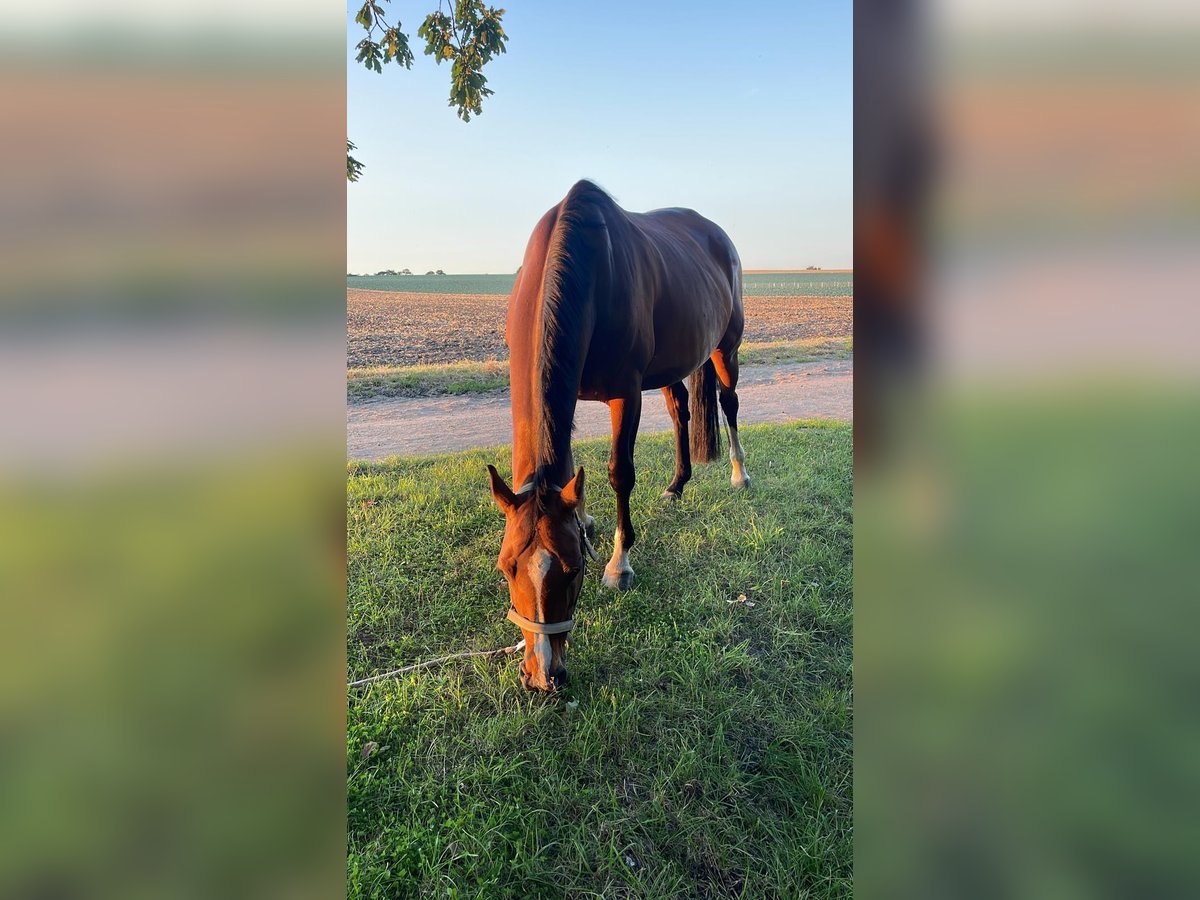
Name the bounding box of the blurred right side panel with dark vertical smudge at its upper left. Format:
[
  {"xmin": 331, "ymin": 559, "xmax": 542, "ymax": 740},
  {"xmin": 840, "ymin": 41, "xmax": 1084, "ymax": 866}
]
[{"xmin": 856, "ymin": 0, "xmax": 1200, "ymax": 898}]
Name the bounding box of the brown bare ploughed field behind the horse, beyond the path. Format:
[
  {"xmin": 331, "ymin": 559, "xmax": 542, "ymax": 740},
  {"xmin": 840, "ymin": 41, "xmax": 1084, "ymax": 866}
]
[{"xmin": 346, "ymin": 290, "xmax": 854, "ymax": 367}]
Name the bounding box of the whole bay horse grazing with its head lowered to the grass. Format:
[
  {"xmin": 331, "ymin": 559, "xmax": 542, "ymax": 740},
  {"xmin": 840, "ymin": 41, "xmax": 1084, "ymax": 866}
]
[{"xmin": 488, "ymin": 181, "xmax": 750, "ymax": 690}]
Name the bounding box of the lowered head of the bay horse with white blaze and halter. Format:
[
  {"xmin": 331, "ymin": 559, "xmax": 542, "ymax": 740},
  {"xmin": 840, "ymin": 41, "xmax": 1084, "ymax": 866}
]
[{"xmin": 487, "ymin": 466, "xmax": 589, "ymax": 691}]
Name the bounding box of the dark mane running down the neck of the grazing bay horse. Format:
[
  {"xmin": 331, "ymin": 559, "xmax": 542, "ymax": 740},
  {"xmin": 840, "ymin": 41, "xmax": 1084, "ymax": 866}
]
[{"xmin": 533, "ymin": 181, "xmax": 617, "ymax": 494}]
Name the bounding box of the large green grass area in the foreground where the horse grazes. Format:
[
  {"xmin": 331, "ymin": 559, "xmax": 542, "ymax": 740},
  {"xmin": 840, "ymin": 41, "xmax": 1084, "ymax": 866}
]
[{"xmin": 347, "ymin": 422, "xmax": 852, "ymax": 898}]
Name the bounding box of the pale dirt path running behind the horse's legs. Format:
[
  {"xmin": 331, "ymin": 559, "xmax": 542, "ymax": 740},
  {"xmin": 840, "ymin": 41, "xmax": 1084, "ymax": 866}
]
[{"xmin": 346, "ymin": 360, "xmax": 853, "ymax": 460}]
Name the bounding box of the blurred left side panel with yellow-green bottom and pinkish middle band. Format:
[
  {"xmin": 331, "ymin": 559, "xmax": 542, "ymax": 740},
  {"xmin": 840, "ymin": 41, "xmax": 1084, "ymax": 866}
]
[{"xmin": 0, "ymin": 0, "xmax": 346, "ymax": 898}]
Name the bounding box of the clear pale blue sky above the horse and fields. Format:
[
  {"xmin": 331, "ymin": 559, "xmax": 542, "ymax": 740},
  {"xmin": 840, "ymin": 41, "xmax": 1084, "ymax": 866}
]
[{"xmin": 347, "ymin": 0, "xmax": 853, "ymax": 272}]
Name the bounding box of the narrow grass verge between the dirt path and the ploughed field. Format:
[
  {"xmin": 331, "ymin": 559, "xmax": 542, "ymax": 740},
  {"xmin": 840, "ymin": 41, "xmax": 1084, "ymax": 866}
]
[{"xmin": 346, "ymin": 337, "xmax": 853, "ymax": 401}]
